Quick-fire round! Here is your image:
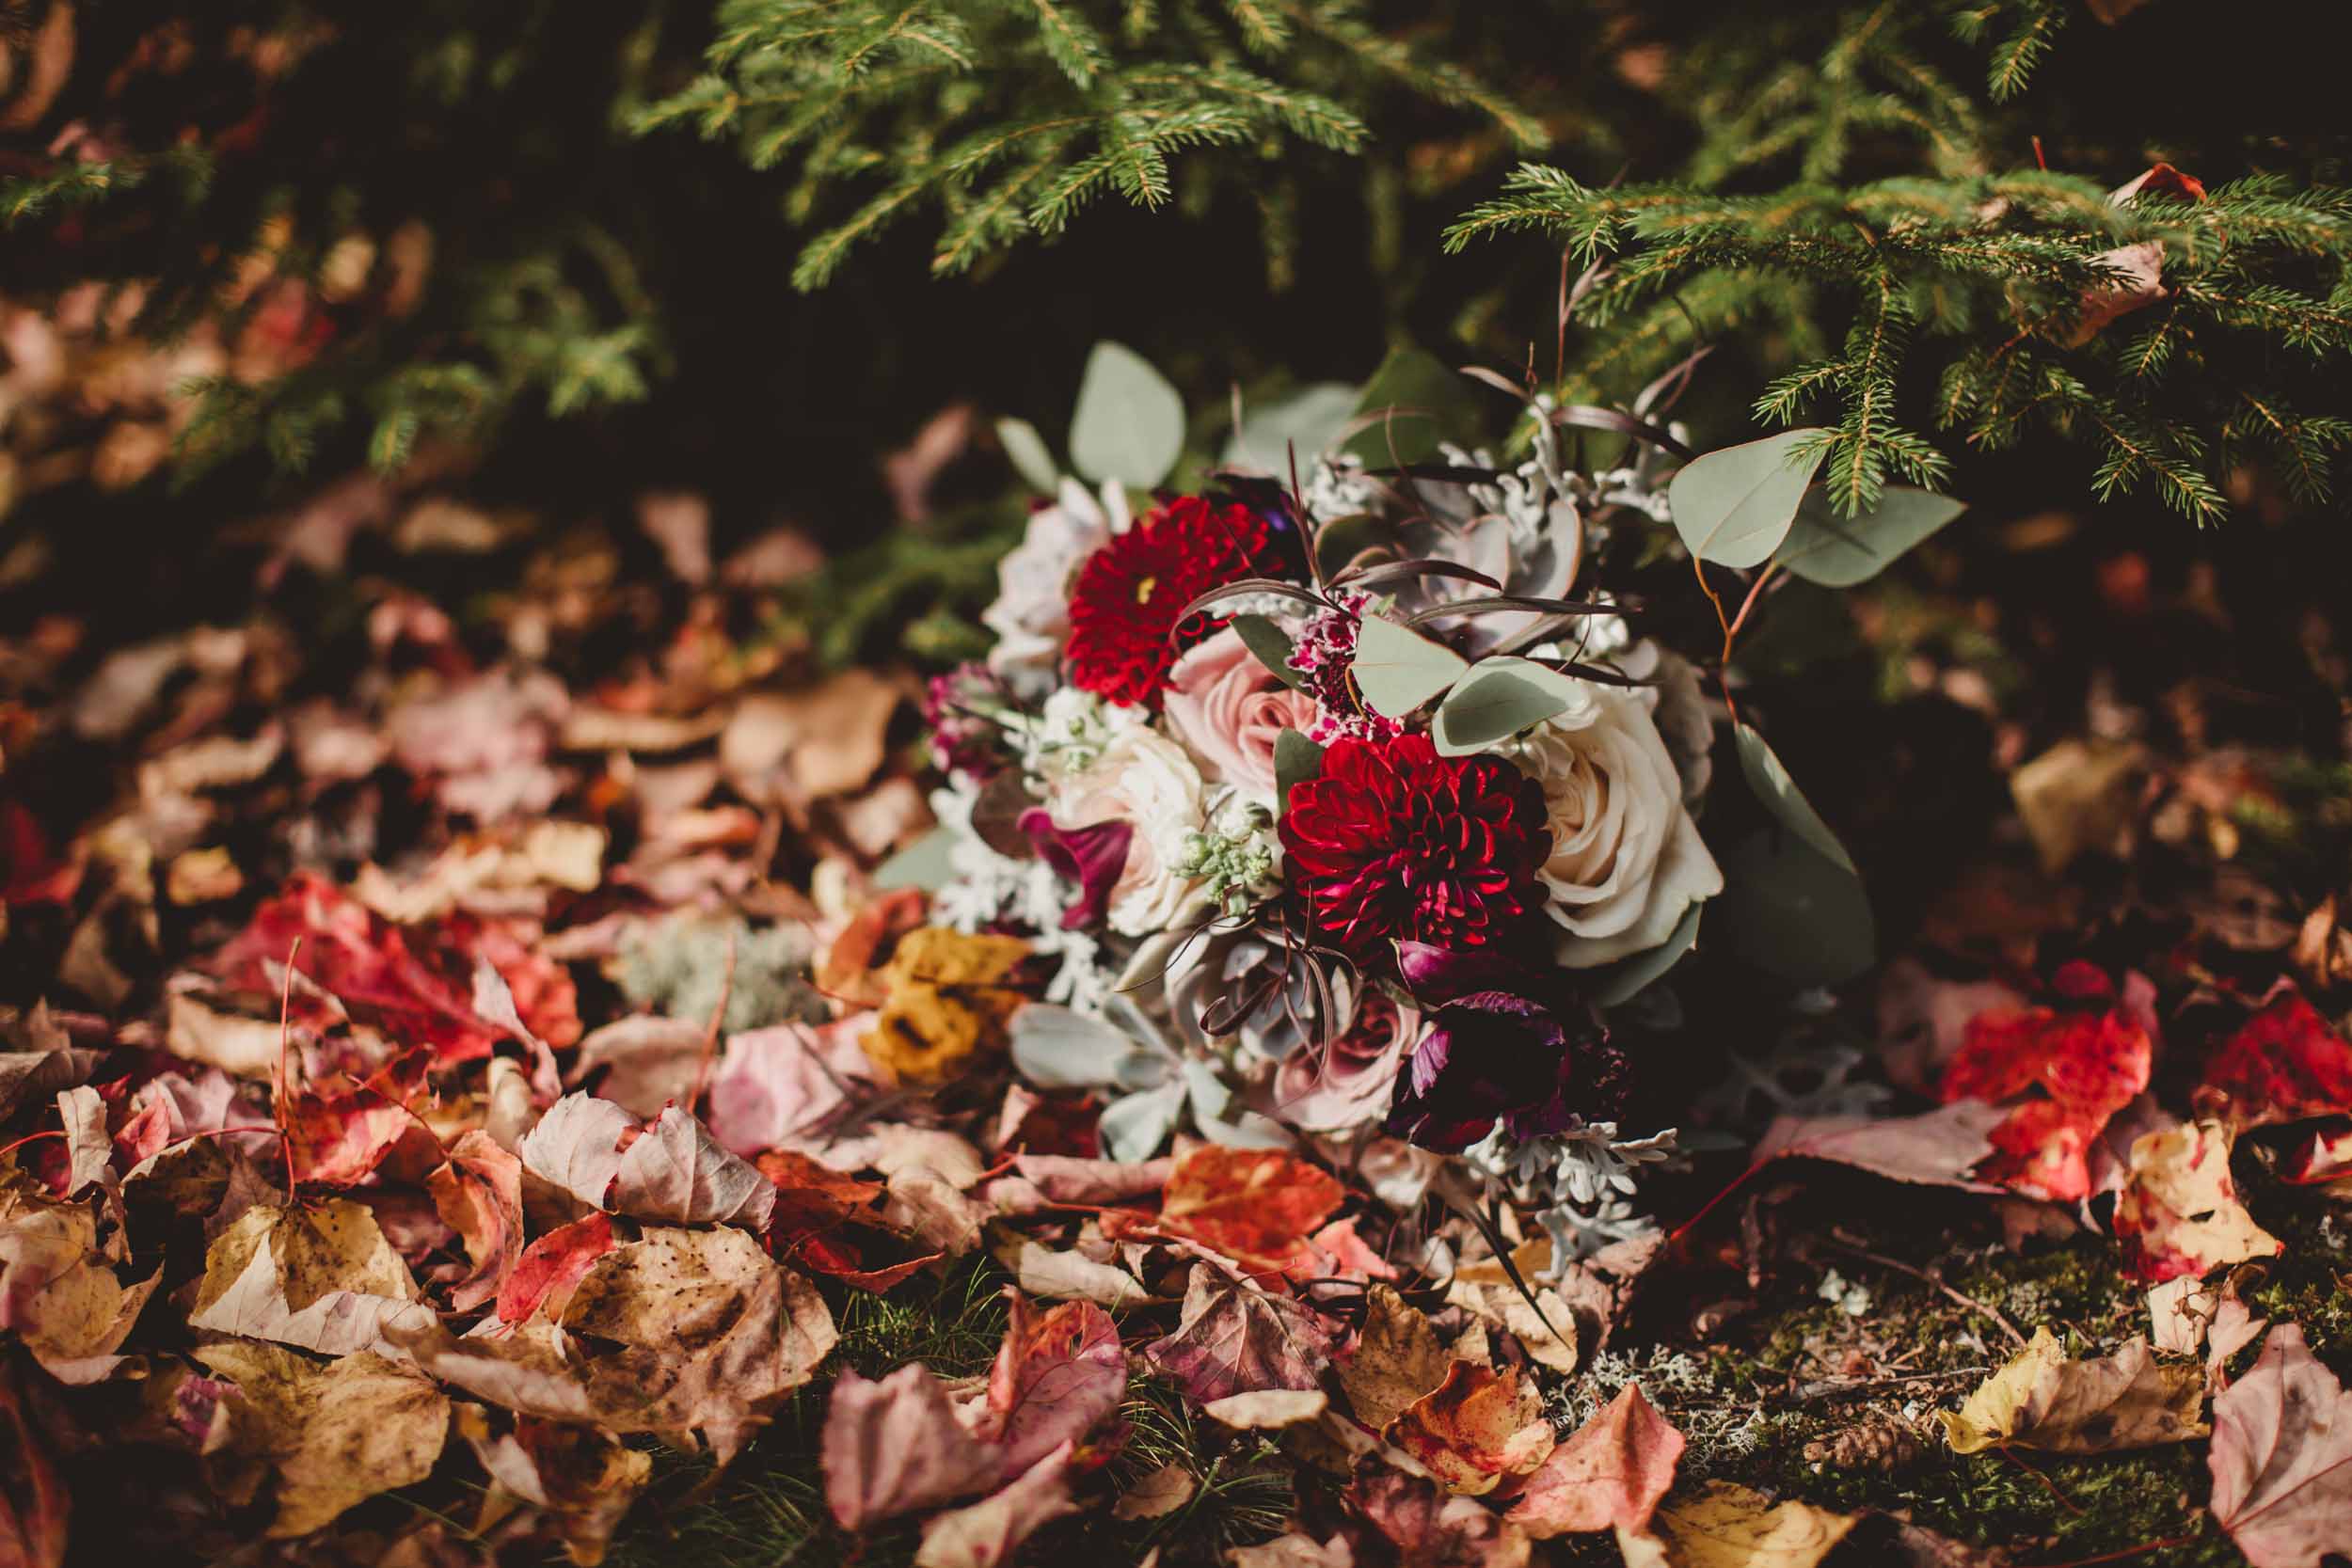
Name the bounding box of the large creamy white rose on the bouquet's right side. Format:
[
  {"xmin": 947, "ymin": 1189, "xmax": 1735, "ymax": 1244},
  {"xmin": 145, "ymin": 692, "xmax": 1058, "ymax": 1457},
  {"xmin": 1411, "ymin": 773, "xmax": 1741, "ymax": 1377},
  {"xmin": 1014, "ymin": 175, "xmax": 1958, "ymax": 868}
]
[{"xmin": 1519, "ymin": 682, "xmax": 1724, "ymax": 969}]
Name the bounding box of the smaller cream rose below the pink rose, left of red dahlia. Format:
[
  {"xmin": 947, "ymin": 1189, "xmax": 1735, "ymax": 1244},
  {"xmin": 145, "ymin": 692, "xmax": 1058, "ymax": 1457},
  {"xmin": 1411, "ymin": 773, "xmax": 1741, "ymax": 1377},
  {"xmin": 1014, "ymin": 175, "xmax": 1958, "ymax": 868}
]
[{"xmin": 1049, "ymin": 729, "xmax": 1204, "ymax": 936}]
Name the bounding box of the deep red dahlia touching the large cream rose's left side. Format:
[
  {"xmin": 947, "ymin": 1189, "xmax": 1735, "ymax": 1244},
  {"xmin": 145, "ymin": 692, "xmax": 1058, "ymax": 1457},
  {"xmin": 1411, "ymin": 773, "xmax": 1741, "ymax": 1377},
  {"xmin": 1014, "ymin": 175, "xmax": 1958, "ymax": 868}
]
[{"xmin": 1282, "ymin": 736, "xmax": 1552, "ymax": 966}]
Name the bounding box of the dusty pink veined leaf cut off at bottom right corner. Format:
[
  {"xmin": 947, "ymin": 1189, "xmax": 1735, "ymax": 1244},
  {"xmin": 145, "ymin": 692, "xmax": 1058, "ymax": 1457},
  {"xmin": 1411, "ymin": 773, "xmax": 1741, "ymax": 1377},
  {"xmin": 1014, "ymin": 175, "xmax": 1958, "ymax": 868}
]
[{"xmin": 2206, "ymin": 1323, "xmax": 2352, "ymax": 1568}]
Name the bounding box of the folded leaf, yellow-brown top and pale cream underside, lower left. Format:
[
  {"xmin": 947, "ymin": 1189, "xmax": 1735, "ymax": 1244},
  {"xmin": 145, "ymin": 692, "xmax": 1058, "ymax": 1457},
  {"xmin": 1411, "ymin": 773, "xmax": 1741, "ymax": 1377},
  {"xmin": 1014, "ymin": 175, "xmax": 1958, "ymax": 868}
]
[{"xmin": 188, "ymin": 1199, "xmax": 436, "ymax": 1356}]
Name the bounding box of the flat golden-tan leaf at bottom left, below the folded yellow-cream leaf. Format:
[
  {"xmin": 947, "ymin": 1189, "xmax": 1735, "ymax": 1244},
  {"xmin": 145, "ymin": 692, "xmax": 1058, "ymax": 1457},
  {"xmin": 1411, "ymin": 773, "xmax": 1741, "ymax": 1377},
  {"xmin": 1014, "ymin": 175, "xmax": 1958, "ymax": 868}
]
[{"xmin": 196, "ymin": 1342, "xmax": 450, "ymax": 1538}]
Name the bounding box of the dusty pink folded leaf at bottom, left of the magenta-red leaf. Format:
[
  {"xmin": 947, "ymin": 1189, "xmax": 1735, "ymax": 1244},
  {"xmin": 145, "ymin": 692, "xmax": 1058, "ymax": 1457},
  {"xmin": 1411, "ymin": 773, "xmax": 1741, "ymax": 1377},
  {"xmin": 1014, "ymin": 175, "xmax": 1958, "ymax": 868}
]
[{"xmin": 821, "ymin": 1361, "xmax": 1005, "ymax": 1530}]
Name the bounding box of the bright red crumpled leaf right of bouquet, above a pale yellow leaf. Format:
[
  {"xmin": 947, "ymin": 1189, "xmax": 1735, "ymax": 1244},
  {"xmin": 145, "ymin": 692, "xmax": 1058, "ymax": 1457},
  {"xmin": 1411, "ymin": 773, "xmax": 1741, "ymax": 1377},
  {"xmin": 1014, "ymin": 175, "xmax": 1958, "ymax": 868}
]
[{"xmin": 1943, "ymin": 1006, "xmax": 2154, "ymax": 1204}]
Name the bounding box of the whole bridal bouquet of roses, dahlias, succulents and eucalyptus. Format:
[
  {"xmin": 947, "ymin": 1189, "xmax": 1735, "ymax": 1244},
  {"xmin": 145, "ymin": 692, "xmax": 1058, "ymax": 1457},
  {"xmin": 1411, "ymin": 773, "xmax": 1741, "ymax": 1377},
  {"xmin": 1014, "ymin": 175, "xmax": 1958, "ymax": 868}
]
[{"xmin": 898, "ymin": 350, "xmax": 1957, "ymax": 1260}]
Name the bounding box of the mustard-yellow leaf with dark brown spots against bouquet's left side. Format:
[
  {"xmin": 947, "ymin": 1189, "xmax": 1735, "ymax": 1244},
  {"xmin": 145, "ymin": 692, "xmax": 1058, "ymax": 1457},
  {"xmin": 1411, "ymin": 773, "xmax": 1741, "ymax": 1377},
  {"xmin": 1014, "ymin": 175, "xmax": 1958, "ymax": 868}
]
[{"xmin": 861, "ymin": 927, "xmax": 1028, "ymax": 1084}]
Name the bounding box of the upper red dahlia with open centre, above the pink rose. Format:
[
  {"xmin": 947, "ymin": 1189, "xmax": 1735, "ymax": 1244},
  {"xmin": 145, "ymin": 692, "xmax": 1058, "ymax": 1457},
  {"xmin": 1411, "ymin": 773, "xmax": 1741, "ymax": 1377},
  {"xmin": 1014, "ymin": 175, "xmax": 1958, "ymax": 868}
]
[{"xmin": 1071, "ymin": 496, "xmax": 1282, "ymax": 707}]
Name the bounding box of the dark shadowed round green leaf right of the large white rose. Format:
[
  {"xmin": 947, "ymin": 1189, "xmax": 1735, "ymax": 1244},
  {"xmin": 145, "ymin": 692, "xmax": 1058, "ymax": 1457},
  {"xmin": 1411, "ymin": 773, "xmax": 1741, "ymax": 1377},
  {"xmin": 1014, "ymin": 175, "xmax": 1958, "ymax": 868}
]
[{"xmin": 1710, "ymin": 825, "xmax": 1877, "ymax": 985}]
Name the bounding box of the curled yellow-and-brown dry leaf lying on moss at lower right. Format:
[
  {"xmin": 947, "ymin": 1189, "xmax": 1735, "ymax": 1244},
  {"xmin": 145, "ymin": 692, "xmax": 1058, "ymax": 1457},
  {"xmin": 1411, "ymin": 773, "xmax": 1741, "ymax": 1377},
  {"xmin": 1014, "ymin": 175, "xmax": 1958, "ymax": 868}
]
[{"xmin": 1938, "ymin": 1328, "xmax": 2206, "ymax": 1453}]
